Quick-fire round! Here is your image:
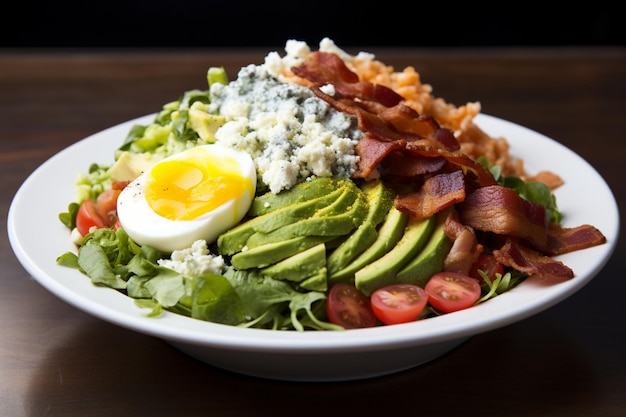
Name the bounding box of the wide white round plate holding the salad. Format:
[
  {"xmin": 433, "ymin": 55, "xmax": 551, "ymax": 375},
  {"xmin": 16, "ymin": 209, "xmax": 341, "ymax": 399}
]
[{"xmin": 8, "ymin": 115, "xmax": 619, "ymax": 381}]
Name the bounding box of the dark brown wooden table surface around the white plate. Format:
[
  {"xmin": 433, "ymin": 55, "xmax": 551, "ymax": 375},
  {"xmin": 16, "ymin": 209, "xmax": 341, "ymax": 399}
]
[{"xmin": 0, "ymin": 48, "xmax": 626, "ymax": 417}]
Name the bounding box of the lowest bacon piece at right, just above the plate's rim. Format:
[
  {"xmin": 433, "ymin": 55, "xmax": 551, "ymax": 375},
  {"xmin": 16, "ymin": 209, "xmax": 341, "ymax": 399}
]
[{"xmin": 493, "ymin": 239, "xmax": 574, "ymax": 279}]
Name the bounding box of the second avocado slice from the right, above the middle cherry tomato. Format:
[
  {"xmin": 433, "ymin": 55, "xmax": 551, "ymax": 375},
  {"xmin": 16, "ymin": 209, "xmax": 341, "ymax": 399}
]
[{"xmin": 354, "ymin": 213, "xmax": 435, "ymax": 296}]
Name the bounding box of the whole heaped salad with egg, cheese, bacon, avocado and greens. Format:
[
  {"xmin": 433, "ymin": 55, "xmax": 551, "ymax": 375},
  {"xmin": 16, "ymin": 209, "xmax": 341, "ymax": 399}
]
[{"xmin": 57, "ymin": 38, "xmax": 606, "ymax": 331}]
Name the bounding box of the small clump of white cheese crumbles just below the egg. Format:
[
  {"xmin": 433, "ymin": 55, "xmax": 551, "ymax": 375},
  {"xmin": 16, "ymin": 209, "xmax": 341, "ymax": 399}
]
[{"xmin": 157, "ymin": 240, "xmax": 226, "ymax": 277}]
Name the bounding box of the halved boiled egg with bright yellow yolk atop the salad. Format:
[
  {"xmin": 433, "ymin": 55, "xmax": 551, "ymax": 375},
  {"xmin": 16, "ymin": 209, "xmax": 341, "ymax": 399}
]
[{"xmin": 117, "ymin": 144, "xmax": 256, "ymax": 252}]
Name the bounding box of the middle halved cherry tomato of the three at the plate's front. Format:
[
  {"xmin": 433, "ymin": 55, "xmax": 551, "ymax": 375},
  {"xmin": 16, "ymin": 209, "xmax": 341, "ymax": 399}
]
[{"xmin": 370, "ymin": 284, "xmax": 428, "ymax": 324}]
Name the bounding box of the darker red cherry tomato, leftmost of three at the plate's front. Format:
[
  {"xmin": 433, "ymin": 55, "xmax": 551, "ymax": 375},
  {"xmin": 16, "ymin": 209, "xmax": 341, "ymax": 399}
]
[{"xmin": 326, "ymin": 283, "xmax": 377, "ymax": 329}]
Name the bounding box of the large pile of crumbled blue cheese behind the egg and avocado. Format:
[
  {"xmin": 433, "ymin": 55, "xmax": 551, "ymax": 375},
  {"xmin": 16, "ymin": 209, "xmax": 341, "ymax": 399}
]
[{"xmin": 210, "ymin": 54, "xmax": 363, "ymax": 193}]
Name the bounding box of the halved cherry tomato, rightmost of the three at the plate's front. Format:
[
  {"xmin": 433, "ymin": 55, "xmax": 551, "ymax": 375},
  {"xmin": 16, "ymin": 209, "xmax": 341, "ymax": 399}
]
[{"xmin": 424, "ymin": 272, "xmax": 480, "ymax": 313}]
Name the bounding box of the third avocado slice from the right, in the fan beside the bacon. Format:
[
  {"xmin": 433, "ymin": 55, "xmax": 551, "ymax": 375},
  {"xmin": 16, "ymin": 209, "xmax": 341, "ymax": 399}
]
[{"xmin": 329, "ymin": 206, "xmax": 409, "ymax": 284}]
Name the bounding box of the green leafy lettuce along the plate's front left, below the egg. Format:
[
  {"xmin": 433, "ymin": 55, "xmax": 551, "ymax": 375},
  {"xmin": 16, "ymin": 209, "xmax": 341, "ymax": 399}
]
[{"xmin": 57, "ymin": 228, "xmax": 343, "ymax": 331}]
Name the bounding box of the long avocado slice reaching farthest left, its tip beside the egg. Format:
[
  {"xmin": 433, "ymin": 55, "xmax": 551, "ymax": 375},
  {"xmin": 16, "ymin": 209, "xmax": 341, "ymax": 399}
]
[{"xmin": 217, "ymin": 188, "xmax": 344, "ymax": 255}]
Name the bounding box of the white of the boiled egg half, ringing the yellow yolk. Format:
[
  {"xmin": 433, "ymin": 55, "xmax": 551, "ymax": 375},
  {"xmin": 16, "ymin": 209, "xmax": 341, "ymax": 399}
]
[{"xmin": 117, "ymin": 144, "xmax": 256, "ymax": 253}]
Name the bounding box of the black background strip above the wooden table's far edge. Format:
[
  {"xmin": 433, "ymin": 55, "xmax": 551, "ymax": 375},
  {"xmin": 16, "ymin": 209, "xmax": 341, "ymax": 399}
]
[{"xmin": 0, "ymin": 0, "xmax": 626, "ymax": 48}]
